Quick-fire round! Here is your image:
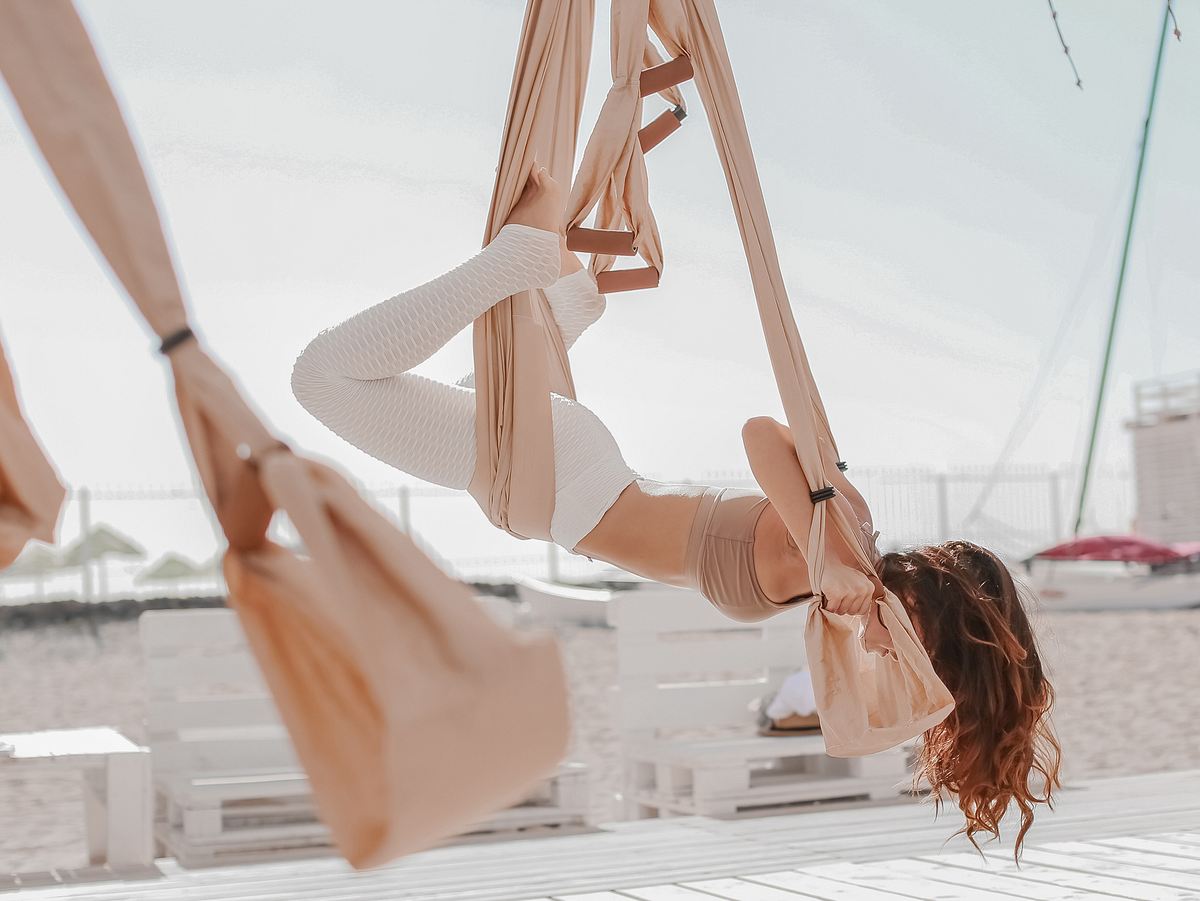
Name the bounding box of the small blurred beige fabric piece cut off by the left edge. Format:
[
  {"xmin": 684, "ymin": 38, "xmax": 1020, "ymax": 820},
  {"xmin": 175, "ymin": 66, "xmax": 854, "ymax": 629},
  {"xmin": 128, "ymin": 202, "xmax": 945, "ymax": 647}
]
[{"xmin": 0, "ymin": 342, "xmax": 66, "ymax": 569}]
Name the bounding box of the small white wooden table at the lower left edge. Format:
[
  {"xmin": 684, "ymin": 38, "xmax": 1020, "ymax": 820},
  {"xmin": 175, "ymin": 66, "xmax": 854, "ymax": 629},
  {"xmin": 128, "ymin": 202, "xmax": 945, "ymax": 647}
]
[{"xmin": 0, "ymin": 727, "xmax": 154, "ymax": 867}]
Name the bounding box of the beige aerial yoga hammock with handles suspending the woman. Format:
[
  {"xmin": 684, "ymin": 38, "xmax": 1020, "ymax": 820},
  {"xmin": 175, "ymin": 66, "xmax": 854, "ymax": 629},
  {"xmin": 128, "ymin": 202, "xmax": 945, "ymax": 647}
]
[{"xmin": 472, "ymin": 0, "xmax": 954, "ymax": 756}]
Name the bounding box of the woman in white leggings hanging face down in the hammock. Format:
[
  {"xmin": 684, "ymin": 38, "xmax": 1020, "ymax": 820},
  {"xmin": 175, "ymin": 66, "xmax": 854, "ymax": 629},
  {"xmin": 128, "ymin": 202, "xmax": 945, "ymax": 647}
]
[{"xmin": 292, "ymin": 169, "xmax": 1058, "ymax": 847}]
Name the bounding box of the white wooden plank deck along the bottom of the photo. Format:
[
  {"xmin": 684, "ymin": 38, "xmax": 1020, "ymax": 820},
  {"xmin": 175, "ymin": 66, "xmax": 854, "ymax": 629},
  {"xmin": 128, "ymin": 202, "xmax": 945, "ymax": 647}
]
[{"xmin": 7, "ymin": 770, "xmax": 1200, "ymax": 901}]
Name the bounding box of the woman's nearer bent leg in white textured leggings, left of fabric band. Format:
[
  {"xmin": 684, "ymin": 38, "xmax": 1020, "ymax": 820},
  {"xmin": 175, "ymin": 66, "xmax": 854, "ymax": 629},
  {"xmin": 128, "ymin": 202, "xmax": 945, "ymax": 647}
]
[{"xmin": 292, "ymin": 224, "xmax": 560, "ymax": 488}]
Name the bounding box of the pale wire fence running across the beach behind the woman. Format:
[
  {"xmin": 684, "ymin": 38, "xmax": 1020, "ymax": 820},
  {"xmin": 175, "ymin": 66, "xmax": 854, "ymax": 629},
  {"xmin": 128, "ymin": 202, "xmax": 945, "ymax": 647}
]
[{"xmin": 0, "ymin": 467, "xmax": 1134, "ymax": 605}]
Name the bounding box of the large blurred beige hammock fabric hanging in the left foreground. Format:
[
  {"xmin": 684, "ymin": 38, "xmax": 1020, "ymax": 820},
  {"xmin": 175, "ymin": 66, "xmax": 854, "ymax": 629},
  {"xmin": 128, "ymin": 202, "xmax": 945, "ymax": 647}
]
[{"xmin": 0, "ymin": 0, "xmax": 568, "ymax": 867}]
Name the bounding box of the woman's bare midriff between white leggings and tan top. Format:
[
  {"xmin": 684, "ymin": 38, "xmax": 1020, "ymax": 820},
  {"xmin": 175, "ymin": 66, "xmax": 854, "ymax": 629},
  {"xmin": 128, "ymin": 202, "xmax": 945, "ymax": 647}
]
[{"xmin": 575, "ymin": 479, "xmax": 704, "ymax": 585}]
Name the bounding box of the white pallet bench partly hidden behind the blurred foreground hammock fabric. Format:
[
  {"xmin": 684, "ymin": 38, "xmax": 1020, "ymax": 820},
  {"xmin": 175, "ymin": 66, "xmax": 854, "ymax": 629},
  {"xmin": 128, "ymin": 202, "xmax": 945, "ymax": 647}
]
[{"xmin": 139, "ymin": 608, "xmax": 588, "ymax": 866}]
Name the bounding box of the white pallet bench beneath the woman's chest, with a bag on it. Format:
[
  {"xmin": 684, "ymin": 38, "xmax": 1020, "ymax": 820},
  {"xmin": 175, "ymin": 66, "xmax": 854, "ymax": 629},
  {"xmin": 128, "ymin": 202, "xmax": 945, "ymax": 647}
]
[{"xmin": 610, "ymin": 584, "xmax": 907, "ymax": 819}]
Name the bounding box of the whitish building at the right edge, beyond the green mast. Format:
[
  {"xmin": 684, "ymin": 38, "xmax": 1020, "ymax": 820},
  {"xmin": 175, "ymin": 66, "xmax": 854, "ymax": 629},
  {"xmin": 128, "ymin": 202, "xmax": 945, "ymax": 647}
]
[{"xmin": 1129, "ymin": 372, "xmax": 1200, "ymax": 542}]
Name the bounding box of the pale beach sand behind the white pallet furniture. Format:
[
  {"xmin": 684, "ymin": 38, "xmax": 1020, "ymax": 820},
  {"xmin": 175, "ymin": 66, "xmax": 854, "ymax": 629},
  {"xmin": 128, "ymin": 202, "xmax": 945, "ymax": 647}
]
[{"xmin": 0, "ymin": 611, "xmax": 1200, "ymax": 872}]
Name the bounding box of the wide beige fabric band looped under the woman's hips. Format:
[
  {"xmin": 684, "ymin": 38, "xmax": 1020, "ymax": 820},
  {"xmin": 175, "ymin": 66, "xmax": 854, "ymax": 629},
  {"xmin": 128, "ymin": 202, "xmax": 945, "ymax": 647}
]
[{"xmin": 468, "ymin": 0, "xmax": 595, "ymax": 541}]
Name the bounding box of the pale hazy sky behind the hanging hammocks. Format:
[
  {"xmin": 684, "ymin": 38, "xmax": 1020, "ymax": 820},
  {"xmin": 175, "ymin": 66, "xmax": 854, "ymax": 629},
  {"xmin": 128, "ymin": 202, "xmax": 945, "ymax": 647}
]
[{"xmin": 0, "ymin": 0, "xmax": 1200, "ymax": 520}]
